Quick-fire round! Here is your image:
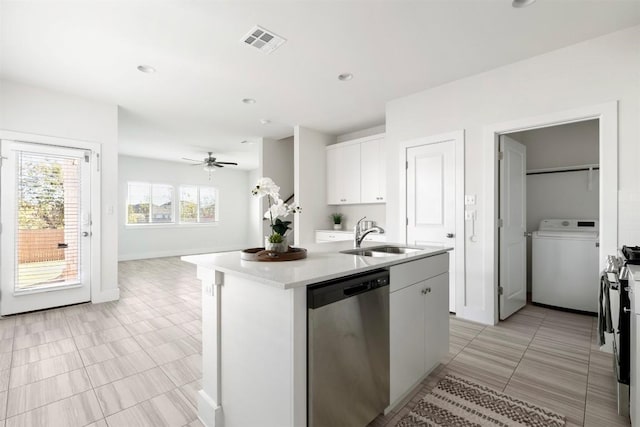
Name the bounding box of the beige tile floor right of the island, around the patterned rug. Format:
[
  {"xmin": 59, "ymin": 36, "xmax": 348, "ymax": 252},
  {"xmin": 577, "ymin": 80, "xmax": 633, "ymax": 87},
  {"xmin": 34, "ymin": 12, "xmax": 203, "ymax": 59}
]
[{"xmin": 370, "ymin": 305, "xmax": 630, "ymax": 427}]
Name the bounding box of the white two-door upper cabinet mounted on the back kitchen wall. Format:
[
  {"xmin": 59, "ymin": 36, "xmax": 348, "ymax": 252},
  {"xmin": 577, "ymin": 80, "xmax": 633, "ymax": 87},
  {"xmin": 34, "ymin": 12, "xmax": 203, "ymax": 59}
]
[{"xmin": 327, "ymin": 135, "xmax": 386, "ymax": 205}]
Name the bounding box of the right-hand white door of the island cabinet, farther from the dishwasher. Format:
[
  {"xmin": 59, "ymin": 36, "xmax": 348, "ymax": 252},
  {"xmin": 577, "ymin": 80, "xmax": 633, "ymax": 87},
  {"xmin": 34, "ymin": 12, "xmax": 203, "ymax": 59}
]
[{"xmin": 423, "ymin": 273, "xmax": 449, "ymax": 373}]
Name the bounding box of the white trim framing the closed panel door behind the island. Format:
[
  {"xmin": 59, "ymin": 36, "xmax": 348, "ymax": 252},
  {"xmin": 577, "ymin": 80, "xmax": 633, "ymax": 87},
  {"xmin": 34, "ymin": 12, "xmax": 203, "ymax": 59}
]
[{"xmin": 398, "ymin": 129, "xmax": 466, "ymax": 317}]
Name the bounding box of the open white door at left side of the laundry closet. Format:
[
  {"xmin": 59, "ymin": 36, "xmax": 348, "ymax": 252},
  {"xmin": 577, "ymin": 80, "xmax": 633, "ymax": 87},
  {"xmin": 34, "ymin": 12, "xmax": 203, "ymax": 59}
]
[{"xmin": 498, "ymin": 135, "xmax": 527, "ymax": 320}]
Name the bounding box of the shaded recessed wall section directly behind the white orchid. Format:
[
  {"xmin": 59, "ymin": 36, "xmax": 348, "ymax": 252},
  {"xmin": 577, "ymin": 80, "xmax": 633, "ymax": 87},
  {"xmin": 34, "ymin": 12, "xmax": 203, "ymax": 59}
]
[{"xmin": 260, "ymin": 137, "xmax": 295, "ymax": 236}]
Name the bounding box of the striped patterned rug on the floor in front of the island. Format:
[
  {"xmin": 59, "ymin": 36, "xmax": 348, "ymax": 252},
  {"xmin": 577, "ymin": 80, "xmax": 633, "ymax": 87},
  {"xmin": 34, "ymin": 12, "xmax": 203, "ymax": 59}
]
[{"xmin": 396, "ymin": 375, "xmax": 565, "ymax": 427}]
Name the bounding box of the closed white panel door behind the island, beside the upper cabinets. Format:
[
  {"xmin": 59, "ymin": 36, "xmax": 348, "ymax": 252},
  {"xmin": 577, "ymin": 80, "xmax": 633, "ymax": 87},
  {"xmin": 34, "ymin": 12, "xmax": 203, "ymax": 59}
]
[{"xmin": 406, "ymin": 140, "xmax": 456, "ymax": 312}]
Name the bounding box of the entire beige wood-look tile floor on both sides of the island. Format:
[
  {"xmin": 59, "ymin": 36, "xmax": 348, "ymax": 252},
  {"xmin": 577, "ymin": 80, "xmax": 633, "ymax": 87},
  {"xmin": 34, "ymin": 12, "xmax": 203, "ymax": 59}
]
[{"xmin": 0, "ymin": 258, "xmax": 629, "ymax": 427}]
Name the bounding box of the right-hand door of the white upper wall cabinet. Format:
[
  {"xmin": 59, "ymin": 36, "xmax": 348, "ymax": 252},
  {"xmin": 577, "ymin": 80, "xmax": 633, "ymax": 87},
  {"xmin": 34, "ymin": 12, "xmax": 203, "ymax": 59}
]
[{"xmin": 360, "ymin": 139, "xmax": 386, "ymax": 203}]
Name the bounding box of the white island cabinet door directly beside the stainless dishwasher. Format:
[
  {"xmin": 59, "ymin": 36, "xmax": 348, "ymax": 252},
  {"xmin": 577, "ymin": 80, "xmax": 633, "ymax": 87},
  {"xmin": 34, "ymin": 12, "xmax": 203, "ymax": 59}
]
[{"xmin": 389, "ymin": 282, "xmax": 425, "ymax": 404}]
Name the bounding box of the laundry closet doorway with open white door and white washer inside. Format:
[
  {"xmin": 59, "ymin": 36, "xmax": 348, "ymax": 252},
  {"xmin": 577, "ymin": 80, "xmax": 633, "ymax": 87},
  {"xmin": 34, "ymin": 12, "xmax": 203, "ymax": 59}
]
[{"xmin": 497, "ymin": 119, "xmax": 600, "ymax": 320}]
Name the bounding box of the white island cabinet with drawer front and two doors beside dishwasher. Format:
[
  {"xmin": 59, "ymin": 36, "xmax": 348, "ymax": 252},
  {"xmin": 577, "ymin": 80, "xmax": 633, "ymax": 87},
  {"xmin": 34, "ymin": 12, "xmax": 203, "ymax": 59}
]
[{"xmin": 389, "ymin": 254, "xmax": 449, "ymax": 408}]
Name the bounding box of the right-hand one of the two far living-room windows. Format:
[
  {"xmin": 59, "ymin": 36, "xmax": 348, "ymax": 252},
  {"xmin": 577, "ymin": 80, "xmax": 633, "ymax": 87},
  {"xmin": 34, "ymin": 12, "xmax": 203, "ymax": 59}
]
[{"xmin": 180, "ymin": 185, "xmax": 218, "ymax": 224}]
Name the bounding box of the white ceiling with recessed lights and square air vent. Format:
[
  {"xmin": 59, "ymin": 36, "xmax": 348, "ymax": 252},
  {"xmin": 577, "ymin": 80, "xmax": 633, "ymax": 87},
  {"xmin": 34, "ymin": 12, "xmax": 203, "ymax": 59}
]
[{"xmin": 0, "ymin": 0, "xmax": 640, "ymax": 168}]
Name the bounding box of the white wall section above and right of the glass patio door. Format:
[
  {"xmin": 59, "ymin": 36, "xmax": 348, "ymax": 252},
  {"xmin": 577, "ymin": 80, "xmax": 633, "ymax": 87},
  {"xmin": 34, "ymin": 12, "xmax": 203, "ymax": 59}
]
[{"xmin": 0, "ymin": 80, "xmax": 119, "ymax": 302}]
